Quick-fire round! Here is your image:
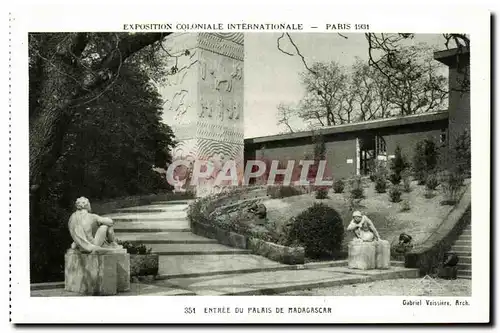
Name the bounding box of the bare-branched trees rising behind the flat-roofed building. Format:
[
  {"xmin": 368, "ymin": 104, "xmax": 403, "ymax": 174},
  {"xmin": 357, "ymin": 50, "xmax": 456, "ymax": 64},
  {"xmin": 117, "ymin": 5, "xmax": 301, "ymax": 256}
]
[{"xmin": 278, "ymin": 40, "xmax": 448, "ymax": 132}]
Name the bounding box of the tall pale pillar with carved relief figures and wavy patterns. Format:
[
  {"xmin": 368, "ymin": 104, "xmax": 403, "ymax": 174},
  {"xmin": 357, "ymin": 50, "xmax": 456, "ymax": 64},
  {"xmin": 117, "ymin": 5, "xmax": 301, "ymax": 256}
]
[{"xmin": 159, "ymin": 33, "xmax": 244, "ymax": 196}]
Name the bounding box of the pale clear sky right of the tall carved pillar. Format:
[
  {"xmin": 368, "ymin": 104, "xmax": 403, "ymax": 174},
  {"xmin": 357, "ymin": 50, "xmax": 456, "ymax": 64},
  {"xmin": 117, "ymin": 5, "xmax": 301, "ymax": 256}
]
[{"xmin": 244, "ymin": 33, "xmax": 445, "ymax": 138}]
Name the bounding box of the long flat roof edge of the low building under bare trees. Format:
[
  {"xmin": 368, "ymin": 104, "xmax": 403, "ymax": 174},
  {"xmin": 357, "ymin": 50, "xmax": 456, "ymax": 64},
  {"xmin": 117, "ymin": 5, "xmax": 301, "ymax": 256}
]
[{"xmin": 245, "ymin": 111, "xmax": 448, "ymax": 144}]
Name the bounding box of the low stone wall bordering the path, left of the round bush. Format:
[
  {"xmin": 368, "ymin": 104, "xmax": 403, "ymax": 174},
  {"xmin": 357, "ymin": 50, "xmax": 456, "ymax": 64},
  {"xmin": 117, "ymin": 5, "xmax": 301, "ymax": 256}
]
[{"xmin": 191, "ymin": 222, "xmax": 305, "ymax": 265}]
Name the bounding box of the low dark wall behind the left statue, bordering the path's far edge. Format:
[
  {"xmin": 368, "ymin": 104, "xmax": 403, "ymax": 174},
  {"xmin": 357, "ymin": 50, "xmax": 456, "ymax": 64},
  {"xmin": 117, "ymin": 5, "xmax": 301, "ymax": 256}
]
[{"xmin": 91, "ymin": 193, "xmax": 193, "ymax": 215}]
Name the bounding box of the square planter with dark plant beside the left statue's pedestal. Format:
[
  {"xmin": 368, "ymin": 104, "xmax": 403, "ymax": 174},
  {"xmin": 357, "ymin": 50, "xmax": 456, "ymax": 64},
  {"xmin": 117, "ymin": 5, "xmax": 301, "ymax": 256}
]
[{"xmin": 119, "ymin": 241, "xmax": 158, "ymax": 277}]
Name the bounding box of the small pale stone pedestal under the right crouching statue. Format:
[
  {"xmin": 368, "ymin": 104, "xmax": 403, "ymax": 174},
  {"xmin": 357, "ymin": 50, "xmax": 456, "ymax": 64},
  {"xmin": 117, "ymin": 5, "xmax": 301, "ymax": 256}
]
[{"xmin": 347, "ymin": 240, "xmax": 391, "ymax": 270}]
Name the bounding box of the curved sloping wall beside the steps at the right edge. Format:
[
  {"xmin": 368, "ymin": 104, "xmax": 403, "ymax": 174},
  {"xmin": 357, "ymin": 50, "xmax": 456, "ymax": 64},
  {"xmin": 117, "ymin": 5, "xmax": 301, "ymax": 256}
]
[{"xmin": 405, "ymin": 185, "xmax": 471, "ymax": 276}]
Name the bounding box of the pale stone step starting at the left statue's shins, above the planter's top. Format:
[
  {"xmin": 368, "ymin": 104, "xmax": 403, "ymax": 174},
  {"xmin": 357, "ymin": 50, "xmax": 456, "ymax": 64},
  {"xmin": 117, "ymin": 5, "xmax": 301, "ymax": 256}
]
[{"xmin": 116, "ymin": 231, "xmax": 217, "ymax": 244}]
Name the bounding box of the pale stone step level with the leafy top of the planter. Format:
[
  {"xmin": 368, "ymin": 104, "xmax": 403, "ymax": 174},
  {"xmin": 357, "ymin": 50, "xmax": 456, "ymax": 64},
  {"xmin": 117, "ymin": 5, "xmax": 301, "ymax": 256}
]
[{"xmin": 149, "ymin": 244, "xmax": 251, "ymax": 254}]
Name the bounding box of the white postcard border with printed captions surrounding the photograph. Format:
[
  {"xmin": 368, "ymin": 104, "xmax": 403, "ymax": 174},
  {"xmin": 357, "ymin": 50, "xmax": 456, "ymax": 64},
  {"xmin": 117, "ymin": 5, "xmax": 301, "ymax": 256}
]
[{"xmin": 10, "ymin": 4, "xmax": 491, "ymax": 323}]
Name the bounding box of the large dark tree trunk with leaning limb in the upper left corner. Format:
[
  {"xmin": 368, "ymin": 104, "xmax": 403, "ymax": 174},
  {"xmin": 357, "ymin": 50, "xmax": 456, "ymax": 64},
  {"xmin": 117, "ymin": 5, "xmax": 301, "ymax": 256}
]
[{"xmin": 29, "ymin": 33, "xmax": 169, "ymax": 194}]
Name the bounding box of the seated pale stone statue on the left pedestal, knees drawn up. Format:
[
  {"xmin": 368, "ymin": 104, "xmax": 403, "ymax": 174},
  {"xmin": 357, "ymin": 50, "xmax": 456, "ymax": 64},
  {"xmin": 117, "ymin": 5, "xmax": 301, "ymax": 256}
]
[{"xmin": 68, "ymin": 197, "xmax": 123, "ymax": 253}]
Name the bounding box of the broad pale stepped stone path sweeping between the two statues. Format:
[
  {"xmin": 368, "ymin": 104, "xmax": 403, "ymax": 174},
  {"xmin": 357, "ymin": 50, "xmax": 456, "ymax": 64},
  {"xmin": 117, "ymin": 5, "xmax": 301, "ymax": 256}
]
[{"xmin": 95, "ymin": 200, "xmax": 418, "ymax": 295}]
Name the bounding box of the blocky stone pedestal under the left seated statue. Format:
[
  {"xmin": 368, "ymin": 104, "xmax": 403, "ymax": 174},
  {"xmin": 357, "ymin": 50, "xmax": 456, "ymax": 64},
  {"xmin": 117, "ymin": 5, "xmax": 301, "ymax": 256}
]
[{"xmin": 64, "ymin": 249, "xmax": 130, "ymax": 296}]
